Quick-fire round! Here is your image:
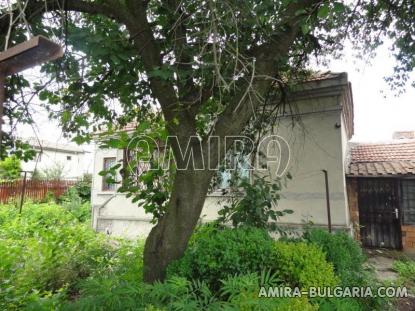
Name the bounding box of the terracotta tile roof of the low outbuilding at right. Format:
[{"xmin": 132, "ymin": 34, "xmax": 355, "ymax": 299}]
[{"xmin": 347, "ymin": 141, "xmax": 415, "ymax": 176}]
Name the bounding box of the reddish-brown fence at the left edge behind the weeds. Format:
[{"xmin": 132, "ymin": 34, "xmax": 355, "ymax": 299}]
[{"xmin": 0, "ymin": 180, "xmax": 76, "ymax": 203}]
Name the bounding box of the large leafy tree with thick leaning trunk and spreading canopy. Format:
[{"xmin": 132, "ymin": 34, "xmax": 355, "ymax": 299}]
[{"xmin": 0, "ymin": 0, "xmax": 415, "ymax": 282}]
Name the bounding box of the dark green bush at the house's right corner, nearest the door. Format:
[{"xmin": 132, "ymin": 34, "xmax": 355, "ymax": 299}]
[{"xmin": 305, "ymin": 229, "xmax": 366, "ymax": 286}]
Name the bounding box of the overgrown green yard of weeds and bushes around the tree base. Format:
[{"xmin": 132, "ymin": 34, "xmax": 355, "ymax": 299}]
[{"xmin": 0, "ymin": 198, "xmax": 415, "ymax": 310}]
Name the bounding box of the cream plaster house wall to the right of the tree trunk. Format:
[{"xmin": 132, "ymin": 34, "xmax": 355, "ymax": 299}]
[{"xmin": 205, "ymin": 97, "xmax": 349, "ymax": 228}]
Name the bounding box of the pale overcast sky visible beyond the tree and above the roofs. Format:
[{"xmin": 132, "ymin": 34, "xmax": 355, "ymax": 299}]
[{"xmin": 18, "ymin": 40, "xmax": 415, "ymax": 144}]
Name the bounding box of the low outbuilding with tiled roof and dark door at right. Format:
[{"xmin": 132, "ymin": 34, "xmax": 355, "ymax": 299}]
[{"xmin": 347, "ymin": 139, "xmax": 415, "ymax": 250}]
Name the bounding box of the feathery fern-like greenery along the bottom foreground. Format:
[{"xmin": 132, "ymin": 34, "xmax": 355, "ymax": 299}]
[{"xmin": 66, "ymin": 273, "xmax": 318, "ymax": 311}]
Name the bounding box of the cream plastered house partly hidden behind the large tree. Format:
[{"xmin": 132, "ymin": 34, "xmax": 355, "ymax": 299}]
[{"xmin": 92, "ymin": 73, "xmax": 353, "ymax": 237}]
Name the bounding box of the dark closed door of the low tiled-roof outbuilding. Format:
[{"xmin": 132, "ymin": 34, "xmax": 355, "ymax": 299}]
[{"xmin": 358, "ymin": 178, "xmax": 402, "ymax": 249}]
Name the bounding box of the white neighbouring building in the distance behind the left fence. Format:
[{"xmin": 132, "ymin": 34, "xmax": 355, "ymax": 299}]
[{"xmin": 22, "ymin": 138, "xmax": 89, "ymax": 179}]
